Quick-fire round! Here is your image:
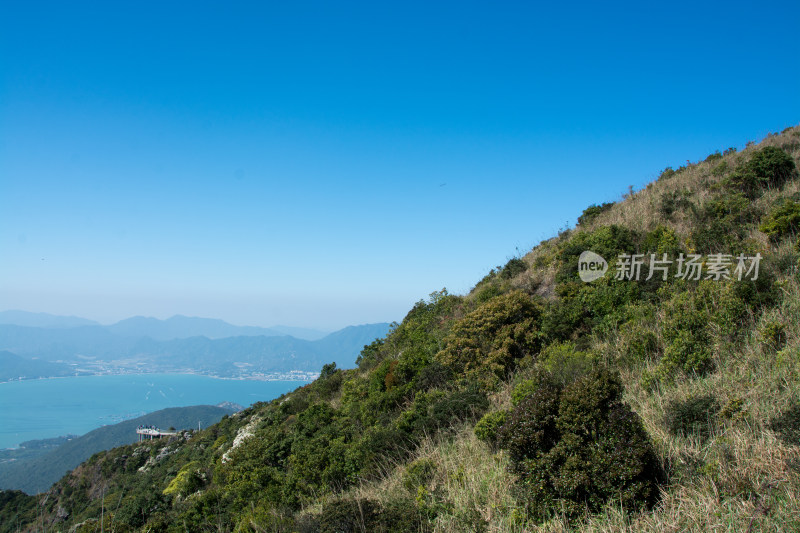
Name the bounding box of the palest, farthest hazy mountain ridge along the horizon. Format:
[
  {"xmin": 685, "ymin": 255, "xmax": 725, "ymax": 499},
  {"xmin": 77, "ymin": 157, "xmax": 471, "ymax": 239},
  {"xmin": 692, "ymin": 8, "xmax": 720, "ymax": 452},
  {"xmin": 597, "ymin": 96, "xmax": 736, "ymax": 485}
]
[{"xmin": 0, "ymin": 310, "xmax": 327, "ymax": 341}]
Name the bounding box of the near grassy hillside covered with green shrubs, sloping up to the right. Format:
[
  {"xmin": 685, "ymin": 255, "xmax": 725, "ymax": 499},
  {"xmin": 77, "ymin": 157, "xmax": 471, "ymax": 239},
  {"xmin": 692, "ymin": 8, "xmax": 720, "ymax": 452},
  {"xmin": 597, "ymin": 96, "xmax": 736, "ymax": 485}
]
[{"xmin": 0, "ymin": 127, "xmax": 800, "ymax": 532}]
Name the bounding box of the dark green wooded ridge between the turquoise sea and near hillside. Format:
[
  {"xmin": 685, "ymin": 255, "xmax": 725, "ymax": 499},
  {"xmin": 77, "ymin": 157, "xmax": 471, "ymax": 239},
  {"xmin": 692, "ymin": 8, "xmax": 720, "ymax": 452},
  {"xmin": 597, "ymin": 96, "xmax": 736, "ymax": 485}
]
[{"xmin": 0, "ymin": 404, "xmax": 241, "ymax": 494}]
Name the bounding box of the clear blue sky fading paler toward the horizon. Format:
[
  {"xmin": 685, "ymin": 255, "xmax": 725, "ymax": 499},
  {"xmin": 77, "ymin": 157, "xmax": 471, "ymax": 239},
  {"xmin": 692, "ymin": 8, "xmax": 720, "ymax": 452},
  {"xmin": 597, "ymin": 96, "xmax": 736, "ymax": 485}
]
[{"xmin": 0, "ymin": 1, "xmax": 800, "ymax": 329}]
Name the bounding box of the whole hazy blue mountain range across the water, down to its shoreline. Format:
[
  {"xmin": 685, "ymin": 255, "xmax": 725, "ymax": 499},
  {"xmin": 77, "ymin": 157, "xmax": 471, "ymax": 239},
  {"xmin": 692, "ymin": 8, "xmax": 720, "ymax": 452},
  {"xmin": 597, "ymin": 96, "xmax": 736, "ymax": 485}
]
[{"xmin": 0, "ymin": 311, "xmax": 389, "ymax": 381}]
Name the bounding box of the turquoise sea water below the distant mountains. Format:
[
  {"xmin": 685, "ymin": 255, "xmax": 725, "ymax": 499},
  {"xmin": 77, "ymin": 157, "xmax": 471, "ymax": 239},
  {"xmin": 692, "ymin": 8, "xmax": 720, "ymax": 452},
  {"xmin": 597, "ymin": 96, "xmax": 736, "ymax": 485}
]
[{"xmin": 0, "ymin": 374, "xmax": 305, "ymax": 448}]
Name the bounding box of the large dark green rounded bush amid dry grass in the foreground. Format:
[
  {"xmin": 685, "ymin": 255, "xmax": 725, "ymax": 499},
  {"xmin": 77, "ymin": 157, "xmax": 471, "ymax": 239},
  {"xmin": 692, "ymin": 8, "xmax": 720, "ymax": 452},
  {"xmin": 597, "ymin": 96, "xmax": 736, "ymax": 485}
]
[{"xmin": 501, "ymin": 369, "xmax": 664, "ymax": 520}]
